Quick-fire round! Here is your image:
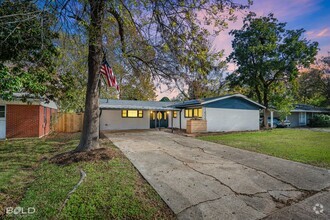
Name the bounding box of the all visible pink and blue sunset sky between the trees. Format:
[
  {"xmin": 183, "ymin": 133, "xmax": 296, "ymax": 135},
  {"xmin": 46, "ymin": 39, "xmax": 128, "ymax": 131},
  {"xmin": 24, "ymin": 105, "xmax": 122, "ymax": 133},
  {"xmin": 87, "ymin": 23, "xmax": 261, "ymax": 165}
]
[{"xmin": 157, "ymin": 0, "xmax": 330, "ymax": 99}]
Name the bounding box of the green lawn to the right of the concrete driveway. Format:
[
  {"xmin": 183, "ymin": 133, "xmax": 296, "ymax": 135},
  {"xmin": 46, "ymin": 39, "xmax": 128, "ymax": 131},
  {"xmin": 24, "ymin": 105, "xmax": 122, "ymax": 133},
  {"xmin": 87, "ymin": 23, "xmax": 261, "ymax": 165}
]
[{"xmin": 198, "ymin": 129, "xmax": 330, "ymax": 168}]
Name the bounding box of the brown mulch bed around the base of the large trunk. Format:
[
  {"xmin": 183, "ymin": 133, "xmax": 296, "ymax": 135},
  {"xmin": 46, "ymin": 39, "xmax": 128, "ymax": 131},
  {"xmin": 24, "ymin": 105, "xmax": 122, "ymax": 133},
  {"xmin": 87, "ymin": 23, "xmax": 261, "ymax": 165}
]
[{"xmin": 49, "ymin": 148, "xmax": 118, "ymax": 165}]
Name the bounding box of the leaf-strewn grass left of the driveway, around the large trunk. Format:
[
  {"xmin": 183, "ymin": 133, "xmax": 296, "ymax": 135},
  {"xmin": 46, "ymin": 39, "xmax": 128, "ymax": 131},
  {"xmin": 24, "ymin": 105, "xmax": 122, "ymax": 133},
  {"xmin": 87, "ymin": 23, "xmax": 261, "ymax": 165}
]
[{"xmin": 0, "ymin": 134, "xmax": 174, "ymax": 219}]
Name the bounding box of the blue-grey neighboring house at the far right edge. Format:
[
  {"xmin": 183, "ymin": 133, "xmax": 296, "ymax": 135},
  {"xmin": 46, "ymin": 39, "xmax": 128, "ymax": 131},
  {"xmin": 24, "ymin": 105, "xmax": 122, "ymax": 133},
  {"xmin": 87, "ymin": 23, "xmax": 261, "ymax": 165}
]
[{"xmin": 275, "ymin": 104, "xmax": 330, "ymax": 127}]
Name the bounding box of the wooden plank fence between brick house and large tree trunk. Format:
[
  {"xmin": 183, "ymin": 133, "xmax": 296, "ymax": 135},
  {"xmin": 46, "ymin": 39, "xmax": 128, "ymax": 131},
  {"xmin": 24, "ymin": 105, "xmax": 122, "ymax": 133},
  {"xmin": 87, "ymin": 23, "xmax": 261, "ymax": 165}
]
[{"xmin": 54, "ymin": 112, "xmax": 84, "ymax": 132}]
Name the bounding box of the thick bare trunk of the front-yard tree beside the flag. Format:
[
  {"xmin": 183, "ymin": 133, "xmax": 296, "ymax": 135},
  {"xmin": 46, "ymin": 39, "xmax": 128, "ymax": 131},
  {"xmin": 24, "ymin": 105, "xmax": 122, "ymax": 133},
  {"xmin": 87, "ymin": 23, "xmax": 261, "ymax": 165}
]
[{"xmin": 76, "ymin": 0, "xmax": 105, "ymax": 151}]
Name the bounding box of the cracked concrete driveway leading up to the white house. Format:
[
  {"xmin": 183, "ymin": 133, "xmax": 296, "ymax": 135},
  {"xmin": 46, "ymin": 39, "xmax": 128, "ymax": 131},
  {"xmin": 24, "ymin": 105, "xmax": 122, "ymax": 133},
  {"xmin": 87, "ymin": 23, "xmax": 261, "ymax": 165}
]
[{"xmin": 106, "ymin": 131, "xmax": 330, "ymax": 219}]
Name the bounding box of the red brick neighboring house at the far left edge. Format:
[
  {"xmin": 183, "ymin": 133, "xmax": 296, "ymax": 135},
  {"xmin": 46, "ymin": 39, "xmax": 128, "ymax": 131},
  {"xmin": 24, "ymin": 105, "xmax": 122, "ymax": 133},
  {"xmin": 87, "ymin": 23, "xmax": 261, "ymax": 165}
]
[{"xmin": 0, "ymin": 93, "xmax": 57, "ymax": 139}]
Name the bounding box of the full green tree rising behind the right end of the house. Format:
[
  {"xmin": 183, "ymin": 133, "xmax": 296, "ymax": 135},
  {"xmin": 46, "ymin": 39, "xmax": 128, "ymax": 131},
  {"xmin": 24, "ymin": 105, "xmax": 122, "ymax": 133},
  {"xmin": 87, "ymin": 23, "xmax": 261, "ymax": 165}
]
[{"xmin": 228, "ymin": 13, "xmax": 318, "ymax": 115}]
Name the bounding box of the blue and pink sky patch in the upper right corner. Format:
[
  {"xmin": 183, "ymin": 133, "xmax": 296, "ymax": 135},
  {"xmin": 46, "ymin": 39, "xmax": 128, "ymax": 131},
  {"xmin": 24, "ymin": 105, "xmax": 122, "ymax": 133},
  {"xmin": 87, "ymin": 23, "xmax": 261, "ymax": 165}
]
[{"xmin": 251, "ymin": 0, "xmax": 330, "ymax": 56}]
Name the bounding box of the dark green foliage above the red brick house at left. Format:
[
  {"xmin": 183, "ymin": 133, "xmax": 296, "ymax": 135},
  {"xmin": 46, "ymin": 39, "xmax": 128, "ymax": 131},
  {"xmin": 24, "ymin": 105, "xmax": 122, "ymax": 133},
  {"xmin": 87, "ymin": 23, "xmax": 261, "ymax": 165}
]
[{"xmin": 0, "ymin": 0, "xmax": 60, "ymax": 100}]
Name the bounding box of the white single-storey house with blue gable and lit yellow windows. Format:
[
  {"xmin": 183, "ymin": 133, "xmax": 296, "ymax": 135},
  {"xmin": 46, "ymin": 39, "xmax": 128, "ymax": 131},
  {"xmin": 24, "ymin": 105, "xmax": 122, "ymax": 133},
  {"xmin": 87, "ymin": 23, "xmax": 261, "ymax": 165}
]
[{"xmin": 100, "ymin": 94, "xmax": 265, "ymax": 132}]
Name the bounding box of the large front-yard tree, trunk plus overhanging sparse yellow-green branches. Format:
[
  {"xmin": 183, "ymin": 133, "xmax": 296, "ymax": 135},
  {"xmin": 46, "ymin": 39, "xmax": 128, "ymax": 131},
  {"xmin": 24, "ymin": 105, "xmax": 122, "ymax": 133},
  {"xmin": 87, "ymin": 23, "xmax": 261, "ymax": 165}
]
[{"xmin": 52, "ymin": 0, "xmax": 250, "ymax": 151}]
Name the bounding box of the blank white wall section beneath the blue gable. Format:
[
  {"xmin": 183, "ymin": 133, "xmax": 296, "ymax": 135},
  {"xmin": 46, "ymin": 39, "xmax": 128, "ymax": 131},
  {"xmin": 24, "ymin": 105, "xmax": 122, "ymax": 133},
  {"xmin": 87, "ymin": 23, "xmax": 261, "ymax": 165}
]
[{"xmin": 206, "ymin": 108, "xmax": 259, "ymax": 132}]
